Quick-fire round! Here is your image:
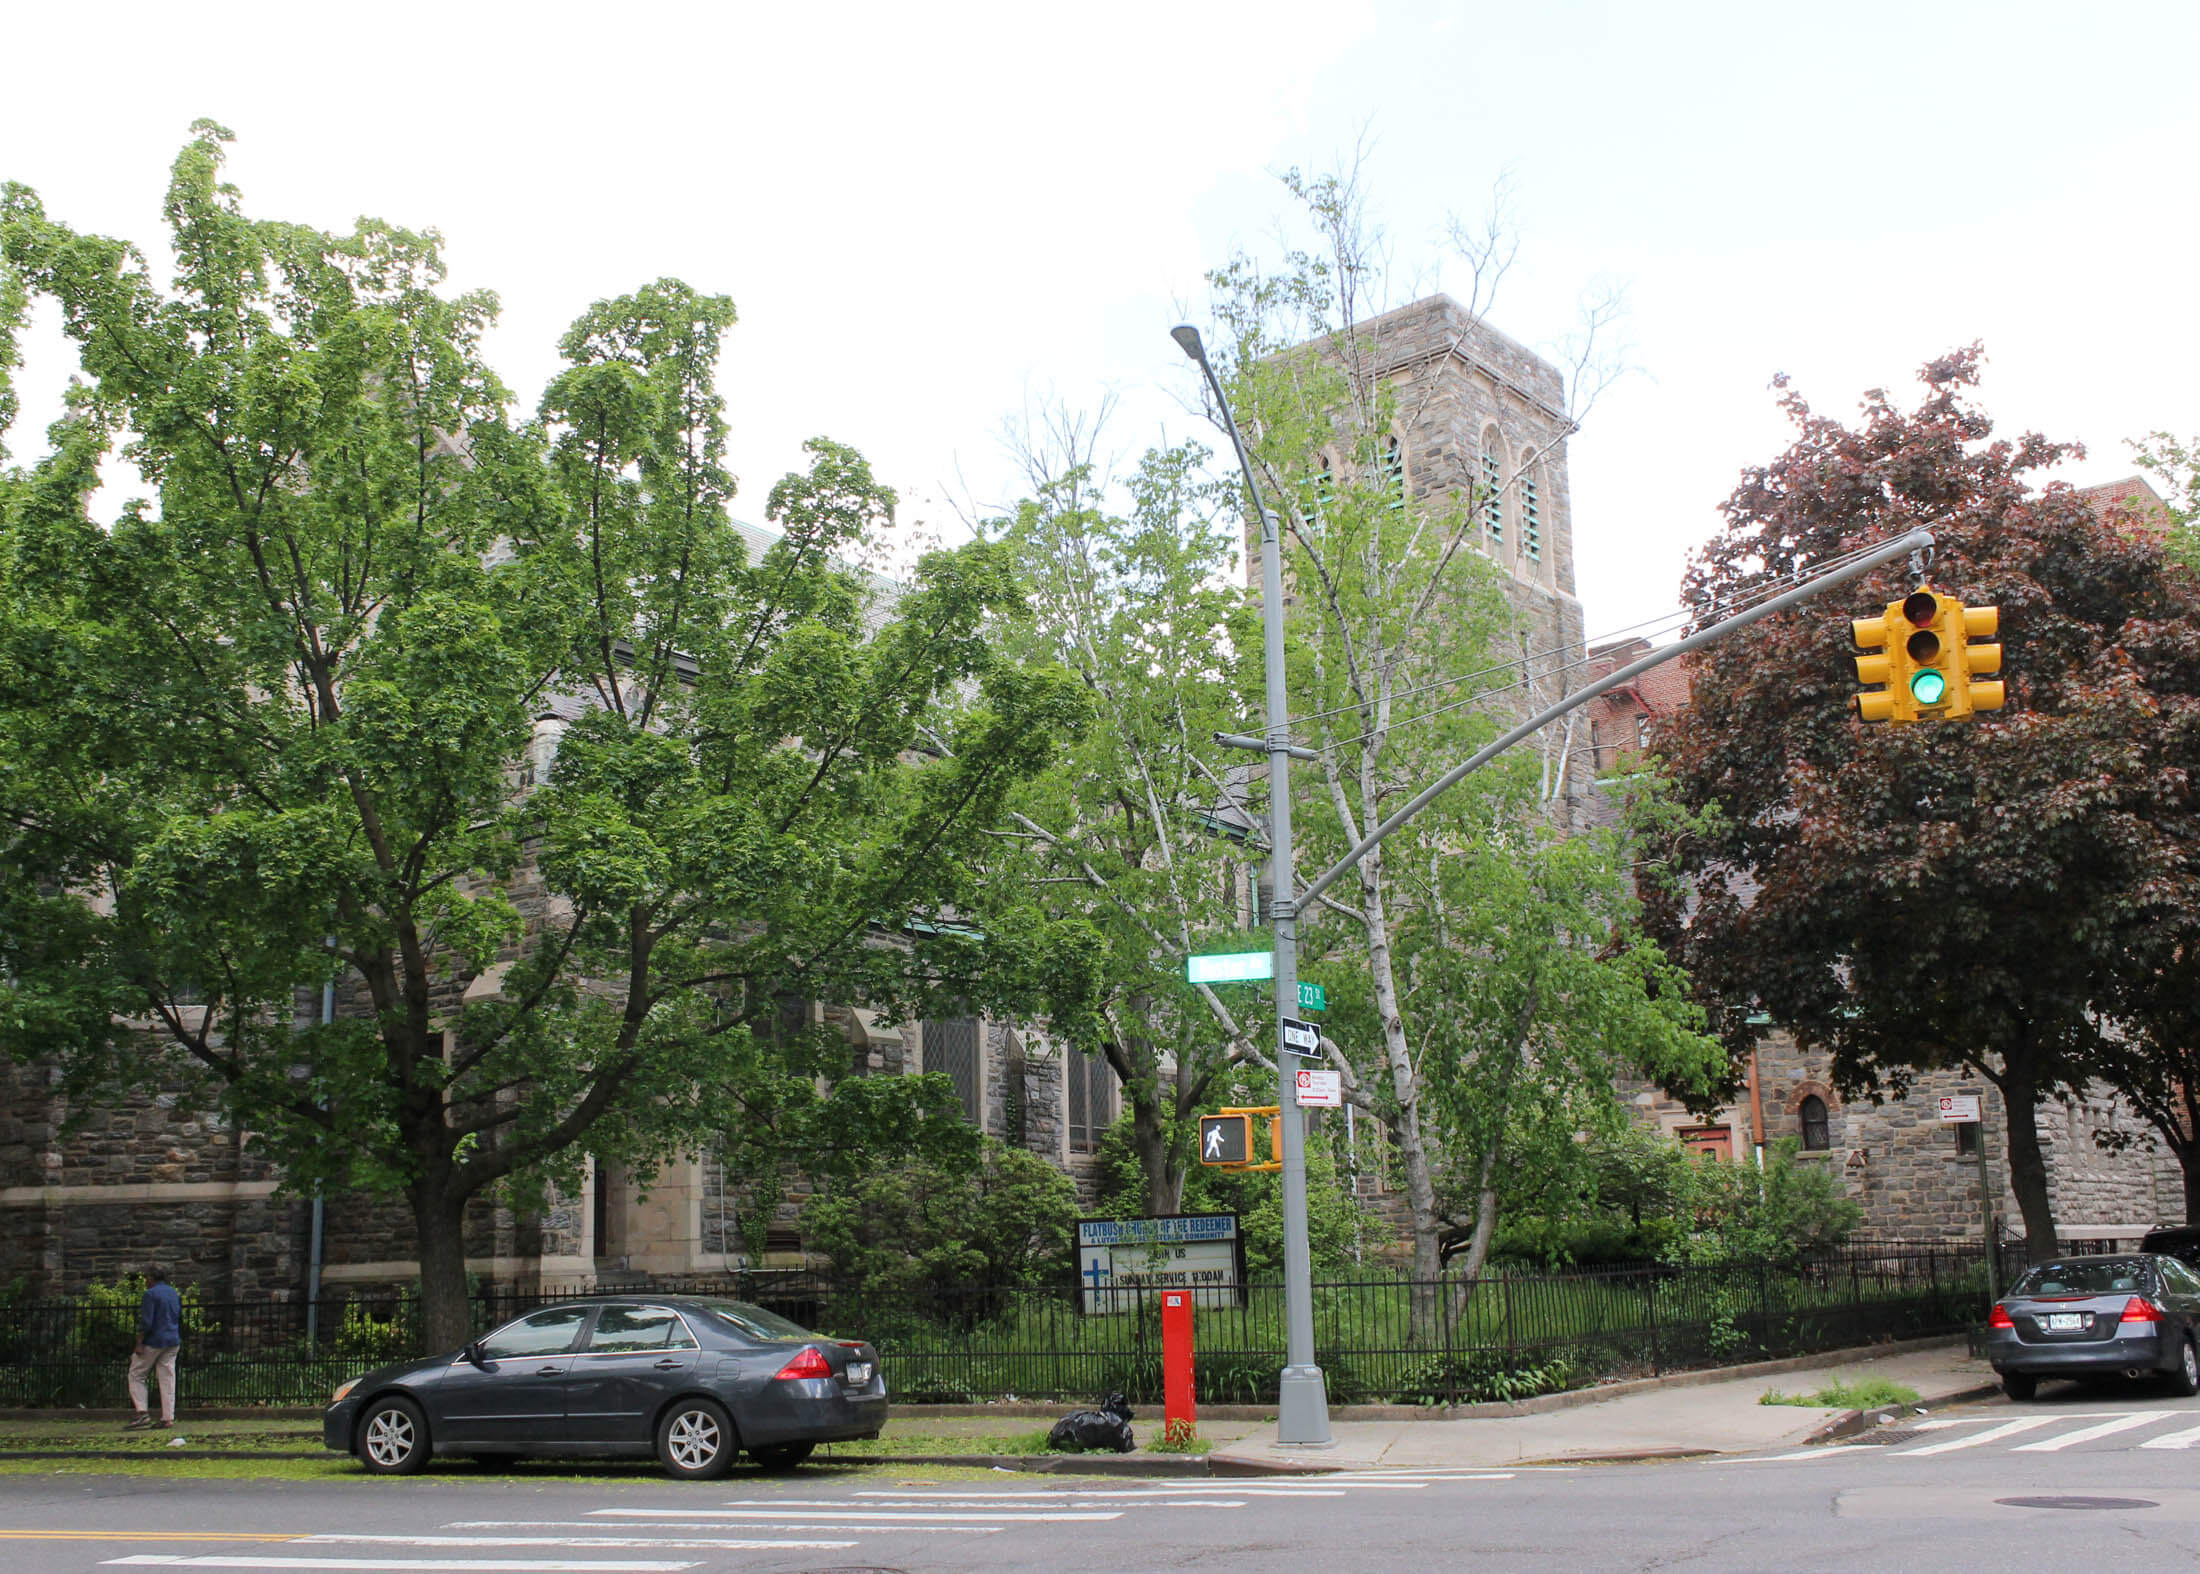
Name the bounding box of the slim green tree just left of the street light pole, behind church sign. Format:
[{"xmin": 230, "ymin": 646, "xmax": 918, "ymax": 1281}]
[{"xmin": 994, "ymin": 416, "xmax": 1274, "ymax": 1215}]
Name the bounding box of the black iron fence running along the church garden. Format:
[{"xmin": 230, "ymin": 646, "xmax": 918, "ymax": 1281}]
[{"xmin": 0, "ymin": 1242, "xmax": 1987, "ymax": 1407}]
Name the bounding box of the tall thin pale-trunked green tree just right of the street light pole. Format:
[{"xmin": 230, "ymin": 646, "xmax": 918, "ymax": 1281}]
[{"xmin": 1212, "ymin": 172, "xmax": 1720, "ymax": 1323}]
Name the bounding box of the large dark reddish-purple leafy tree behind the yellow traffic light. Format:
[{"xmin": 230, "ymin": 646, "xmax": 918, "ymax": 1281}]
[{"xmin": 1657, "ymin": 348, "xmax": 2200, "ymax": 1248}]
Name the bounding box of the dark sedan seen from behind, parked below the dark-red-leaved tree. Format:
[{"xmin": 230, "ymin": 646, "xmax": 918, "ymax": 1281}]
[{"xmin": 1987, "ymin": 1253, "xmax": 2200, "ymax": 1400}]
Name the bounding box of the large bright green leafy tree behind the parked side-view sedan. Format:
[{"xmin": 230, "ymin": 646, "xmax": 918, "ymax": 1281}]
[{"xmin": 0, "ymin": 123, "xmax": 1085, "ymax": 1343}]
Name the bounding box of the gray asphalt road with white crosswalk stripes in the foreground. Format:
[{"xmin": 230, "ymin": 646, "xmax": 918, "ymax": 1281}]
[{"xmin": 0, "ymin": 1389, "xmax": 2200, "ymax": 1574}]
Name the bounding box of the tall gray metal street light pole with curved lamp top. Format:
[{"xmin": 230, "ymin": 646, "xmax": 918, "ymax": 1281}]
[{"xmin": 1168, "ymin": 324, "xmax": 1331, "ymax": 1446}]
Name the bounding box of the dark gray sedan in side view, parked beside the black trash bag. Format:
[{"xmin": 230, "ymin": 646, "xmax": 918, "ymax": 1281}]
[{"xmin": 321, "ymin": 1297, "xmax": 887, "ymax": 1479}]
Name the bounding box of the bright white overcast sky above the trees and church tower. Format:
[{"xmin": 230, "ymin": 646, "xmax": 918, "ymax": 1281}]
[{"xmin": 0, "ymin": 0, "xmax": 2200, "ymax": 632}]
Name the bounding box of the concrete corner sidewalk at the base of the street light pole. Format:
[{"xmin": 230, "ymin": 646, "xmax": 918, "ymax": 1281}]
[{"xmin": 1208, "ymin": 1341, "xmax": 1993, "ymax": 1473}]
